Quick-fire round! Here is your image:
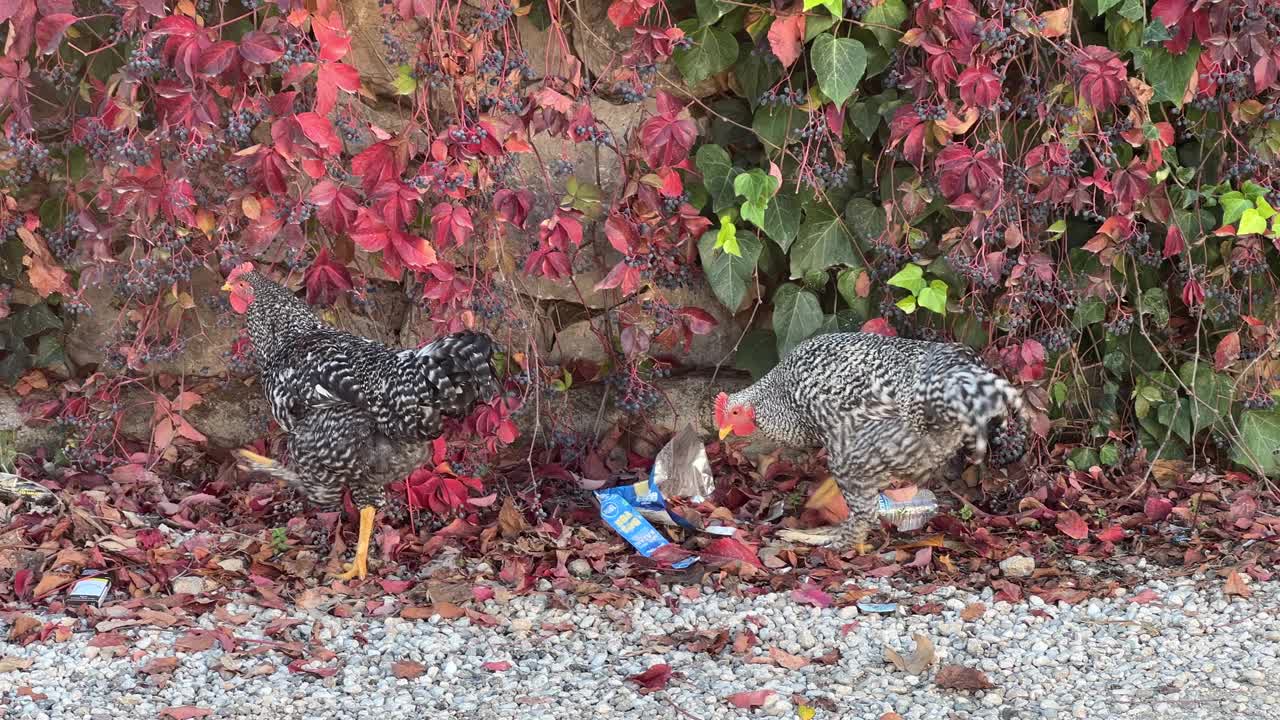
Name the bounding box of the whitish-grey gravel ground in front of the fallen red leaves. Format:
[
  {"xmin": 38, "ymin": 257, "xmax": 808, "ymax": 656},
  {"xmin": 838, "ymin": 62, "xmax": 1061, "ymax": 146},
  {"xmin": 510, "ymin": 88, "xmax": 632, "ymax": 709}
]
[{"xmin": 0, "ymin": 568, "xmax": 1280, "ymax": 720}]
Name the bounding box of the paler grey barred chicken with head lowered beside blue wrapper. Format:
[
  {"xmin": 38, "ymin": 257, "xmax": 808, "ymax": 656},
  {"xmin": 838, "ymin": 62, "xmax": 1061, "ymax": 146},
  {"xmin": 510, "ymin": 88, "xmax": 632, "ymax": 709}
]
[{"xmin": 714, "ymin": 333, "xmax": 1025, "ymax": 553}]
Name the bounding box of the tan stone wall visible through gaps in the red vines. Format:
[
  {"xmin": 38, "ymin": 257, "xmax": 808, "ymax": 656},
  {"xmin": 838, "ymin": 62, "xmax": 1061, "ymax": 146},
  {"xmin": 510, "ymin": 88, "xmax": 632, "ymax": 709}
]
[{"xmin": 10, "ymin": 0, "xmax": 750, "ymax": 451}]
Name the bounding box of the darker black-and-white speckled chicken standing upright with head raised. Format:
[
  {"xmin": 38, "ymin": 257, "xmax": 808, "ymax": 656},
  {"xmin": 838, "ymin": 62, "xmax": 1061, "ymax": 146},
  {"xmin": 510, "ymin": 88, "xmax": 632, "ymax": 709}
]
[{"xmin": 223, "ymin": 263, "xmax": 499, "ymax": 579}]
